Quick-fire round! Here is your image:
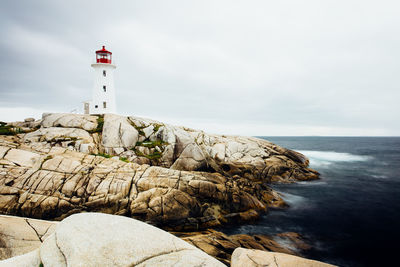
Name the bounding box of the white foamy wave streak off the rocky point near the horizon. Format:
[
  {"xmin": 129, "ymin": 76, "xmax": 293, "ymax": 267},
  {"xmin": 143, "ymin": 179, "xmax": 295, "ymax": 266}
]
[{"xmin": 299, "ymin": 150, "xmax": 372, "ymax": 166}]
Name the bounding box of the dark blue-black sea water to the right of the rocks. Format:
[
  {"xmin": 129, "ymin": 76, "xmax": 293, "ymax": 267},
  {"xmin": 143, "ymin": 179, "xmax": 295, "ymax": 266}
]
[{"xmin": 227, "ymin": 137, "xmax": 400, "ymax": 266}]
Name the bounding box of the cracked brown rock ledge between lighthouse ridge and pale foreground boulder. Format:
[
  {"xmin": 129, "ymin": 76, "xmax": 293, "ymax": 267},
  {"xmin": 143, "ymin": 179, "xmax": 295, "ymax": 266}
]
[{"xmin": 0, "ymin": 146, "xmax": 268, "ymax": 230}]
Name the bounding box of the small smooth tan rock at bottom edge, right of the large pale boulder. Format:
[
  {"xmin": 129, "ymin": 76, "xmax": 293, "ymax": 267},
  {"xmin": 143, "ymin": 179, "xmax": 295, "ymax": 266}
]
[{"xmin": 231, "ymin": 248, "xmax": 334, "ymax": 267}]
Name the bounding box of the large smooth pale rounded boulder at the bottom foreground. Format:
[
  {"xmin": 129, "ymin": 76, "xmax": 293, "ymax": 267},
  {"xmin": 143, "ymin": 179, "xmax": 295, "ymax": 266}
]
[{"xmin": 0, "ymin": 213, "xmax": 225, "ymax": 267}]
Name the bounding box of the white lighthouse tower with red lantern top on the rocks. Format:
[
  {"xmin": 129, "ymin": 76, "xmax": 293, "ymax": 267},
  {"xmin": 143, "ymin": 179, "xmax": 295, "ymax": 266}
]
[{"xmin": 84, "ymin": 46, "xmax": 117, "ymax": 114}]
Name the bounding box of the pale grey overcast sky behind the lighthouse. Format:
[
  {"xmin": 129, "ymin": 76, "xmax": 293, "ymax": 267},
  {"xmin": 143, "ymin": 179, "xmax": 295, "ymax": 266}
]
[{"xmin": 0, "ymin": 0, "xmax": 400, "ymax": 135}]
